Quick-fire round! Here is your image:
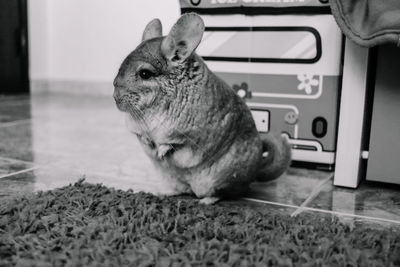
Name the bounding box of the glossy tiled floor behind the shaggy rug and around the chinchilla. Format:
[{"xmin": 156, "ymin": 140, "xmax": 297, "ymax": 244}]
[{"xmin": 0, "ymin": 88, "xmax": 400, "ymax": 230}]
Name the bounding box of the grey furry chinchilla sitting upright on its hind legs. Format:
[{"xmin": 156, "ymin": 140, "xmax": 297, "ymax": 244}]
[{"xmin": 114, "ymin": 13, "xmax": 291, "ymax": 204}]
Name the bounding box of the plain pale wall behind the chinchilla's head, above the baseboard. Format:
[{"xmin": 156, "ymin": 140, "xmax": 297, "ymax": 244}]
[{"xmin": 28, "ymin": 0, "xmax": 179, "ymax": 82}]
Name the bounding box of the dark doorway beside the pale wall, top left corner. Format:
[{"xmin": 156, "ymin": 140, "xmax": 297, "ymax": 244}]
[{"xmin": 0, "ymin": 0, "xmax": 29, "ymax": 94}]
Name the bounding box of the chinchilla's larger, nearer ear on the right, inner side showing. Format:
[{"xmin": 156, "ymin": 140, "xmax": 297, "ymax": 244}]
[{"xmin": 161, "ymin": 13, "xmax": 204, "ymax": 65}]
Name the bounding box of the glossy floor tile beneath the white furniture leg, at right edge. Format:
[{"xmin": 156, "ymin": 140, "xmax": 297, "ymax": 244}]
[{"xmin": 308, "ymin": 181, "xmax": 400, "ymax": 225}]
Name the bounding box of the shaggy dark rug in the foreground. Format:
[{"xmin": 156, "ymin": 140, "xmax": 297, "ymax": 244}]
[{"xmin": 0, "ymin": 181, "xmax": 400, "ymax": 266}]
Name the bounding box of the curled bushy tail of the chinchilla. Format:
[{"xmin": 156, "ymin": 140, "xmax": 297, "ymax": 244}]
[{"xmin": 256, "ymin": 133, "xmax": 292, "ymax": 182}]
